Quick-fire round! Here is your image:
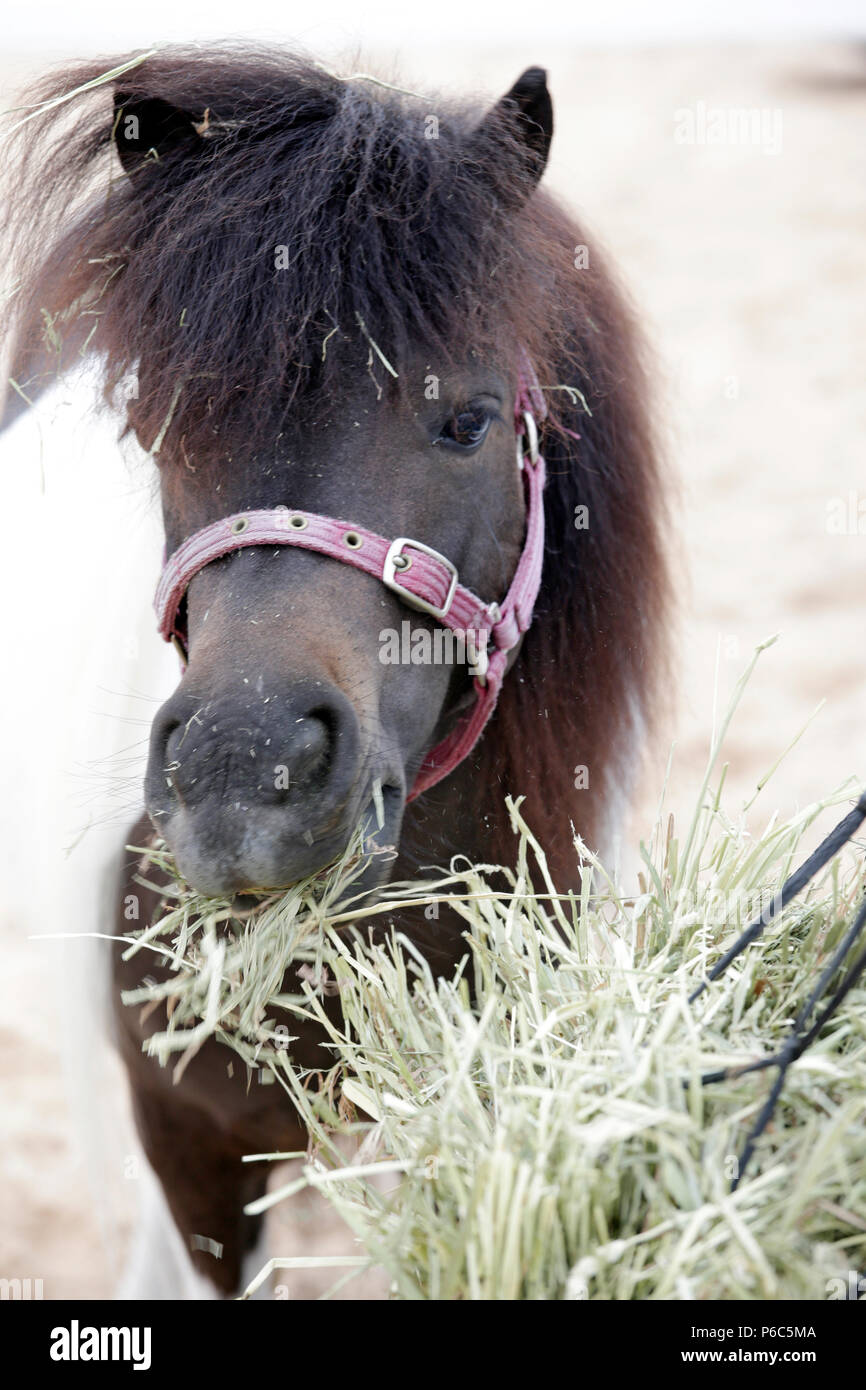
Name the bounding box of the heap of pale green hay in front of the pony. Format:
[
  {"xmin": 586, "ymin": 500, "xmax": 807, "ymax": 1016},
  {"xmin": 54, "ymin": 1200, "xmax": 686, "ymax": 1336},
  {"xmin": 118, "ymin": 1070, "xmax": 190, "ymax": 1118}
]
[{"xmin": 123, "ymin": 644, "xmax": 866, "ymax": 1300}]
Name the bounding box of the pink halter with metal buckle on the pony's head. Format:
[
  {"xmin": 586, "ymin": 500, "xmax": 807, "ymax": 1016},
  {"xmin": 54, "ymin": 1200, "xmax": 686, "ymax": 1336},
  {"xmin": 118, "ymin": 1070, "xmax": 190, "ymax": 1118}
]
[{"xmin": 154, "ymin": 353, "xmax": 546, "ymax": 801}]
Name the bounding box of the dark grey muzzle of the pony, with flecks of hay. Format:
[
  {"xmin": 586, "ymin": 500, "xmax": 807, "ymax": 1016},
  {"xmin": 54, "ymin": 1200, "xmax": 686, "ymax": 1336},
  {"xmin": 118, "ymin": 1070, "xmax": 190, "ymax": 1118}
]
[{"xmin": 146, "ymin": 681, "xmax": 383, "ymax": 895}]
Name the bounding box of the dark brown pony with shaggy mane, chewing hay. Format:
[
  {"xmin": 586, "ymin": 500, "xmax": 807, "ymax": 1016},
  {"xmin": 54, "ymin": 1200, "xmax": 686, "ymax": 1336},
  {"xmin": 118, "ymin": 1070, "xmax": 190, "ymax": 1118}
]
[{"xmin": 7, "ymin": 49, "xmax": 670, "ymax": 1297}]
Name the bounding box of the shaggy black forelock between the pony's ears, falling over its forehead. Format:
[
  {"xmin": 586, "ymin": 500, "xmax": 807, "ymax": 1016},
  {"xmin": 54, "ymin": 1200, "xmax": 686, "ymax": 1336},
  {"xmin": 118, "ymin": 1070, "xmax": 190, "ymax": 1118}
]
[{"xmin": 10, "ymin": 50, "xmax": 572, "ymax": 457}]
